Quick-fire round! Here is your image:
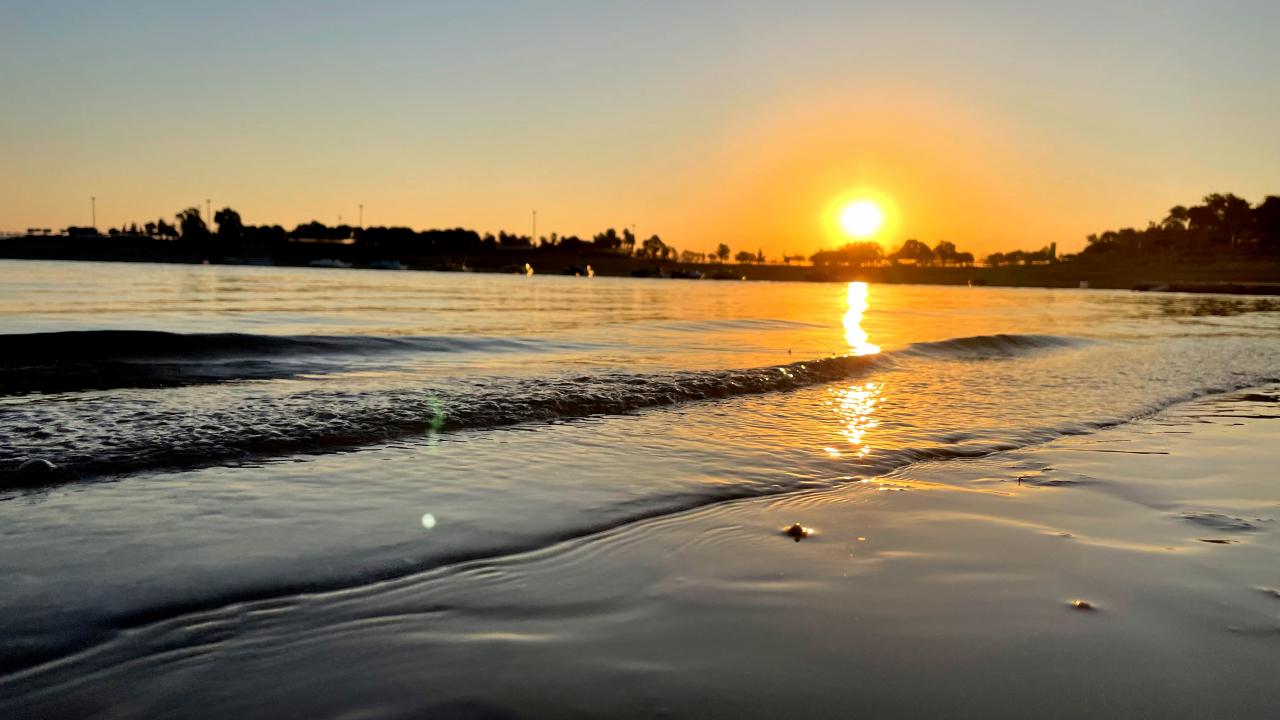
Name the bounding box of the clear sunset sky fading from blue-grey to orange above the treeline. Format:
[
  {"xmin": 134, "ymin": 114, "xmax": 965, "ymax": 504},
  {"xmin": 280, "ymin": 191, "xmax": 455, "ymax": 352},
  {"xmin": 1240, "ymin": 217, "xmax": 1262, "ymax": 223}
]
[{"xmin": 0, "ymin": 0, "xmax": 1280, "ymax": 256}]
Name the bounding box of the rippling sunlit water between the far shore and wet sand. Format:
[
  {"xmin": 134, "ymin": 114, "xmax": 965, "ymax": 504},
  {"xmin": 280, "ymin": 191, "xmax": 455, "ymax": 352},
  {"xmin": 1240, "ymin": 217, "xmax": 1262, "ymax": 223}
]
[{"xmin": 0, "ymin": 261, "xmax": 1280, "ymax": 696}]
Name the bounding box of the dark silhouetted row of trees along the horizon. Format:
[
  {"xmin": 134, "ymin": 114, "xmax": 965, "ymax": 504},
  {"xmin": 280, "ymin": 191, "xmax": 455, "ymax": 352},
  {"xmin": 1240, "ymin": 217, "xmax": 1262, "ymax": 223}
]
[{"xmin": 49, "ymin": 193, "xmax": 1280, "ymax": 266}]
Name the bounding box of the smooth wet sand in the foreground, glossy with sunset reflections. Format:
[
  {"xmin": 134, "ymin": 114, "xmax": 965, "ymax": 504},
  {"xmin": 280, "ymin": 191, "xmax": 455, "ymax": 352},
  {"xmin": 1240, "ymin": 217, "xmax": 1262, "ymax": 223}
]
[{"xmin": 0, "ymin": 387, "xmax": 1280, "ymax": 717}]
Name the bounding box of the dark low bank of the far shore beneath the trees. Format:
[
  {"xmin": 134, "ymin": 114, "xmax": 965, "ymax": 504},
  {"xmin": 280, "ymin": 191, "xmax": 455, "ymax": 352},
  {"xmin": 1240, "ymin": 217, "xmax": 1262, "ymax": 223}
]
[{"xmin": 0, "ymin": 236, "xmax": 1280, "ymax": 295}]
